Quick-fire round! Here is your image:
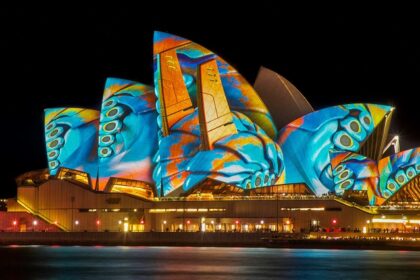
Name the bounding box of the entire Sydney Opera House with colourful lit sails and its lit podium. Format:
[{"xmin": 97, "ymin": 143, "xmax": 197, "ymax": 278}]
[{"xmin": 0, "ymin": 32, "xmax": 420, "ymax": 232}]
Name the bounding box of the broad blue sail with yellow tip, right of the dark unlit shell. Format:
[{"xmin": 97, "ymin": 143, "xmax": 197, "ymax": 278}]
[{"xmin": 279, "ymin": 104, "xmax": 392, "ymax": 195}]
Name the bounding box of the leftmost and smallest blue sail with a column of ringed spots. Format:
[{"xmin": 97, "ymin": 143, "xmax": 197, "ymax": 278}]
[{"xmin": 44, "ymin": 108, "xmax": 99, "ymax": 180}]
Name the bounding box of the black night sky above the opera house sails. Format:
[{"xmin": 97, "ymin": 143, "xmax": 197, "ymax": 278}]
[{"xmin": 0, "ymin": 4, "xmax": 420, "ymax": 197}]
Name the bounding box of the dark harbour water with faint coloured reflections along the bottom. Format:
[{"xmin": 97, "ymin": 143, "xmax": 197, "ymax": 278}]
[{"xmin": 0, "ymin": 246, "xmax": 420, "ymax": 280}]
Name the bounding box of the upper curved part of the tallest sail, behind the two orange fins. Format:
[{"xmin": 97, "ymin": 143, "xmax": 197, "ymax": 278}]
[{"xmin": 153, "ymin": 31, "xmax": 277, "ymax": 139}]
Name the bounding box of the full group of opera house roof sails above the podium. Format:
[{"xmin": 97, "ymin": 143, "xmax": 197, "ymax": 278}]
[{"xmin": 40, "ymin": 32, "xmax": 420, "ymax": 205}]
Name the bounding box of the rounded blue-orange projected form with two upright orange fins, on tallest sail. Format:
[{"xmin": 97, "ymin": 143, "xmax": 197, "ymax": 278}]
[{"xmin": 154, "ymin": 50, "xmax": 283, "ymax": 195}]
